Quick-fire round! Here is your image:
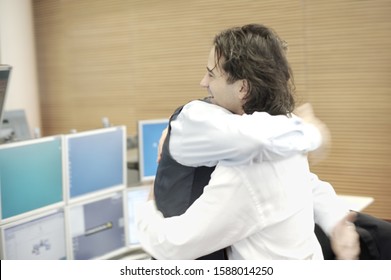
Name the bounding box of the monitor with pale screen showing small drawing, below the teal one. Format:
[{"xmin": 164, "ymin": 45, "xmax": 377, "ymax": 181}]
[{"xmin": 0, "ymin": 209, "xmax": 68, "ymax": 260}]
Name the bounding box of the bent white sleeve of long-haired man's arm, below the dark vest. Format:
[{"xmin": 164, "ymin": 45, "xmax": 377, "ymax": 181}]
[{"xmin": 136, "ymin": 165, "xmax": 258, "ymax": 259}]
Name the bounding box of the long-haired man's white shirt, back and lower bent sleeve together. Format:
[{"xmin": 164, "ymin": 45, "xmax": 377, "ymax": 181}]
[{"xmin": 137, "ymin": 155, "xmax": 323, "ymax": 260}]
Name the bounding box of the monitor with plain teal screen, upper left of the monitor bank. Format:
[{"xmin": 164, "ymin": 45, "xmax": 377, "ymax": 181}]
[{"xmin": 0, "ymin": 136, "xmax": 64, "ymax": 223}]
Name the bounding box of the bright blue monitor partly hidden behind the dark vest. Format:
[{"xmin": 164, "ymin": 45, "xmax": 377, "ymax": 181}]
[{"xmin": 138, "ymin": 119, "xmax": 169, "ymax": 182}]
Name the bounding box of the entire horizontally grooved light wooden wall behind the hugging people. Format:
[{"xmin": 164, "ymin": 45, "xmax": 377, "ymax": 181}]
[{"xmin": 33, "ymin": 0, "xmax": 391, "ymax": 219}]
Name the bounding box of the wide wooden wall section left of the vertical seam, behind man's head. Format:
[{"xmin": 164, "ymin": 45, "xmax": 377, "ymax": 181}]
[{"xmin": 34, "ymin": 0, "xmax": 303, "ymax": 134}]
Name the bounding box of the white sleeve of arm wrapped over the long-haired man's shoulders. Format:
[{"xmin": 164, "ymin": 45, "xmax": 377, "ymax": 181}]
[{"xmin": 170, "ymin": 100, "xmax": 322, "ymax": 166}]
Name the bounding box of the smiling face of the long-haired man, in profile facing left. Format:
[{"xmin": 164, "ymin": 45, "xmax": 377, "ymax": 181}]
[{"xmin": 200, "ymin": 48, "xmax": 246, "ymax": 114}]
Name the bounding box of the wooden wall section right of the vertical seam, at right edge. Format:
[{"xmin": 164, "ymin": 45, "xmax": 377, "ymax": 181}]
[{"xmin": 304, "ymin": 0, "xmax": 391, "ymax": 219}]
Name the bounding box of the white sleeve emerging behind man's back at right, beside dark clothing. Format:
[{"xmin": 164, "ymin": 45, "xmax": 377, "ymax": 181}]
[{"xmin": 311, "ymin": 173, "xmax": 349, "ymax": 236}]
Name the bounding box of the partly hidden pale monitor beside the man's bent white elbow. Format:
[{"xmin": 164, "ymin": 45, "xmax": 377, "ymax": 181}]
[{"xmin": 127, "ymin": 185, "xmax": 151, "ymax": 247}]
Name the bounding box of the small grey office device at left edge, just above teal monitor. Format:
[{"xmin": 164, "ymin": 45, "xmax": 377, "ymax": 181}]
[{"xmin": 0, "ymin": 110, "xmax": 32, "ymax": 142}]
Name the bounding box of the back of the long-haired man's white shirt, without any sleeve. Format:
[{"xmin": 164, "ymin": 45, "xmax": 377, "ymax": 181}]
[{"xmin": 214, "ymin": 155, "xmax": 322, "ymax": 259}]
